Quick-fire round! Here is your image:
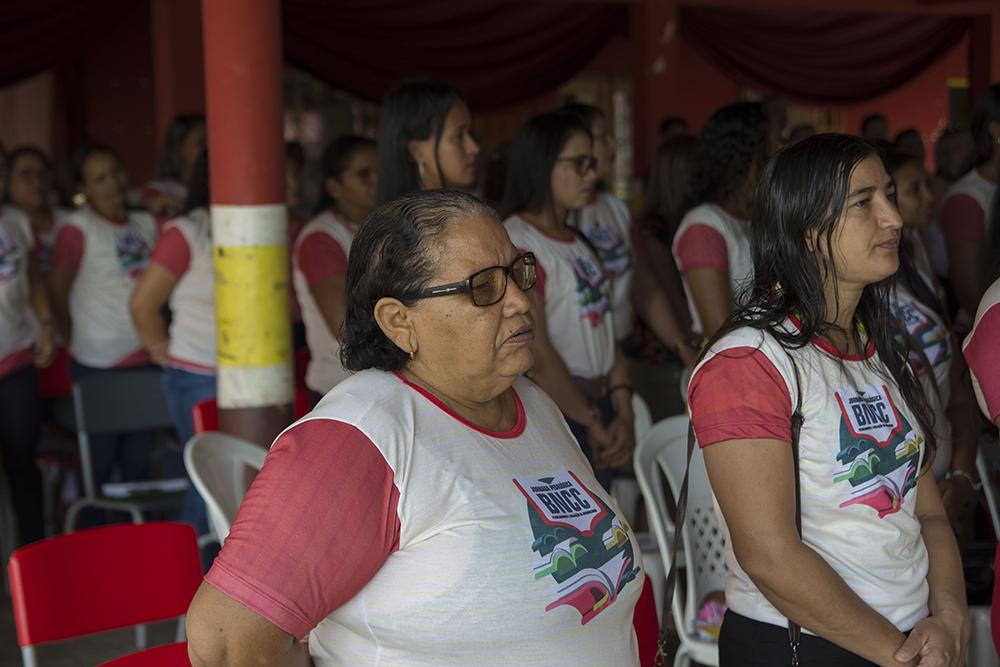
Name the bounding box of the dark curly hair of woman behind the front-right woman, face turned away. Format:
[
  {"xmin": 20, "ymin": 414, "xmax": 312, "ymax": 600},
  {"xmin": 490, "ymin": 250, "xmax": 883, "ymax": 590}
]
[{"xmin": 688, "ymin": 102, "xmax": 768, "ymax": 208}]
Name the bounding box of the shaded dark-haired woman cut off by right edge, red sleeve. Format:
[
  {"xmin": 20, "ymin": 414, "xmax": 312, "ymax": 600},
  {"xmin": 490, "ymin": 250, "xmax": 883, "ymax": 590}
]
[{"xmin": 941, "ymin": 83, "xmax": 1000, "ymax": 330}]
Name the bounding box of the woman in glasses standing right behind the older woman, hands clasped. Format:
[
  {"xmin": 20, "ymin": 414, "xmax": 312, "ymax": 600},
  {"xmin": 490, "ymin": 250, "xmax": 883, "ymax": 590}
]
[{"xmin": 501, "ymin": 113, "xmax": 635, "ymax": 485}]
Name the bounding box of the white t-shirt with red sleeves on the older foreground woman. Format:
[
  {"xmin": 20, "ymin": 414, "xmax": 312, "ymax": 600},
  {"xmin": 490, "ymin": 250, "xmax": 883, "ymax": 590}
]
[{"xmin": 206, "ymin": 370, "xmax": 644, "ymax": 667}]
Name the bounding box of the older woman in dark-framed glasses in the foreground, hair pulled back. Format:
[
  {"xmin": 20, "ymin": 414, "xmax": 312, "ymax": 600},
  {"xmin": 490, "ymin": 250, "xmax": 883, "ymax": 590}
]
[{"xmin": 188, "ymin": 190, "xmax": 643, "ymax": 666}]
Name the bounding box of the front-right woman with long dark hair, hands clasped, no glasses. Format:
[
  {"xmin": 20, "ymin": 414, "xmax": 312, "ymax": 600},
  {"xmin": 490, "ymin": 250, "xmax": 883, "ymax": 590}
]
[{"xmin": 689, "ymin": 134, "xmax": 969, "ymax": 667}]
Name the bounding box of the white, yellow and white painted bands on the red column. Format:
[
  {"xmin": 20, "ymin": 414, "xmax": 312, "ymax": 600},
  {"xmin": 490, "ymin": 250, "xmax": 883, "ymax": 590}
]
[{"xmin": 212, "ymin": 205, "xmax": 294, "ymax": 408}]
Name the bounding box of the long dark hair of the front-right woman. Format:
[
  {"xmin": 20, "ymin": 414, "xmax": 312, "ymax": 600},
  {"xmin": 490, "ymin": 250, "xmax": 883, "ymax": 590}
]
[{"xmin": 702, "ymin": 134, "xmax": 936, "ymax": 460}]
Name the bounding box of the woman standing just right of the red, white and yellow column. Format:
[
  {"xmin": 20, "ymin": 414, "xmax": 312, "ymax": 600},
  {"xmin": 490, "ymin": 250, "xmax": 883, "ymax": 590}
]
[{"xmin": 292, "ymin": 135, "xmax": 378, "ymax": 403}]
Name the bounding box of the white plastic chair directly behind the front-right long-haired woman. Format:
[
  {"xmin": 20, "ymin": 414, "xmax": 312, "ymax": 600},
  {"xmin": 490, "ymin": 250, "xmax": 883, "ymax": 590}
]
[{"xmin": 635, "ymin": 415, "xmax": 726, "ymax": 666}]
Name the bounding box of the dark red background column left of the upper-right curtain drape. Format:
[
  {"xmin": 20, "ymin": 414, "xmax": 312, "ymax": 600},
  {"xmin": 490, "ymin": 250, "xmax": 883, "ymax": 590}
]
[{"xmin": 629, "ymin": 0, "xmax": 680, "ymax": 174}]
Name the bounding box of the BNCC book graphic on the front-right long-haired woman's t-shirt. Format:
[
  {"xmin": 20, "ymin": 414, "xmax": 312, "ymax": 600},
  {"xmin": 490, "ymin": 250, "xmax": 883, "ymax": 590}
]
[{"xmin": 833, "ymin": 384, "xmax": 924, "ymax": 519}]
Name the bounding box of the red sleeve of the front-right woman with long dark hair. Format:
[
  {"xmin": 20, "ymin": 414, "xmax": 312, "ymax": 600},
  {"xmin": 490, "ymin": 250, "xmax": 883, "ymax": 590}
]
[{"xmin": 688, "ymin": 347, "xmax": 792, "ymax": 447}]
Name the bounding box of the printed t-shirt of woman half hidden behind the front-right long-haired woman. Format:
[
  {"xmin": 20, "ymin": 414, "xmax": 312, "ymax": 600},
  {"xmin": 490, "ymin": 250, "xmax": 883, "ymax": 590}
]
[{"xmin": 890, "ymin": 283, "xmax": 957, "ymax": 479}]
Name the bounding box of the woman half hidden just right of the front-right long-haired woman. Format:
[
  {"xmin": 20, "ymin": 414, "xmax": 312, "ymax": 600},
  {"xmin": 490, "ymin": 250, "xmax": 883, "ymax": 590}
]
[{"xmin": 885, "ymin": 153, "xmax": 979, "ymax": 534}]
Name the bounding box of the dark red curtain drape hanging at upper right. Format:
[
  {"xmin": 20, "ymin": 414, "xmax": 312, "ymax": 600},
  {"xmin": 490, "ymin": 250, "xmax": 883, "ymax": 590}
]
[{"xmin": 680, "ymin": 8, "xmax": 971, "ymax": 104}]
